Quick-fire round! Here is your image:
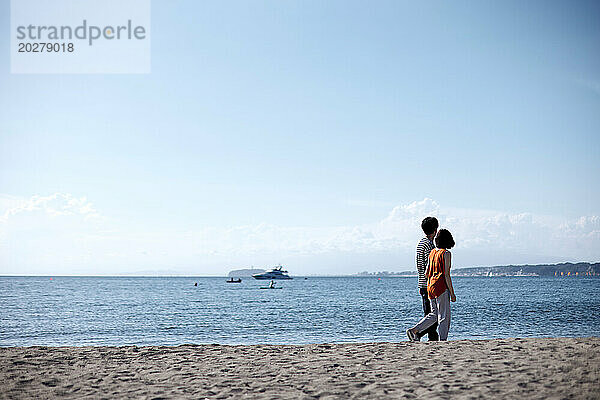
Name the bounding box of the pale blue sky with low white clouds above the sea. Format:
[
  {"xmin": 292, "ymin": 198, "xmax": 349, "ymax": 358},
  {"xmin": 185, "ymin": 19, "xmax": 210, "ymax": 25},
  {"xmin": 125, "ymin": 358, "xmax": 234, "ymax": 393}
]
[{"xmin": 0, "ymin": 0, "xmax": 600, "ymax": 275}]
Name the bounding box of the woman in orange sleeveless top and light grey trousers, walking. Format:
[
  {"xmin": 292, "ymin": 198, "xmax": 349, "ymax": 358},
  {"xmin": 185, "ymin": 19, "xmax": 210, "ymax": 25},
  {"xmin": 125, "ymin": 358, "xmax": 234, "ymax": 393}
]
[{"xmin": 406, "ymin": 229, "xmax": 456, "ymax": 341}]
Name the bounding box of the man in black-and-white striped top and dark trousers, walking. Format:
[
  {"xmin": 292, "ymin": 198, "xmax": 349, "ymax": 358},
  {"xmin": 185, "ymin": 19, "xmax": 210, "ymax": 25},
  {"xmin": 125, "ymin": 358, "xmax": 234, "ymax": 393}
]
[{"xmin": 415, "ymin": 217, "xmax": 439, "ymax": 341}]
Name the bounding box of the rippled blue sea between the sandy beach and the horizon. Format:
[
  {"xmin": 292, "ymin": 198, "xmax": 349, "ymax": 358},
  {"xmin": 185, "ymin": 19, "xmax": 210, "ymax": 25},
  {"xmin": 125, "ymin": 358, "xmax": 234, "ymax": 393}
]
[{"xmin": 0, "ymin": 277, "xmax": 600, "ymax": 346}]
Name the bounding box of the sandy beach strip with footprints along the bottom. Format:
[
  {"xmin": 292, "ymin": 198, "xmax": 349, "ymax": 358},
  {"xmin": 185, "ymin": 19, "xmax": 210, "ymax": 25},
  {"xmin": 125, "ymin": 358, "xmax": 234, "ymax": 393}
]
[{"xmin": 0, "ymin": 338, "xmax": 600, "ymax": 399}]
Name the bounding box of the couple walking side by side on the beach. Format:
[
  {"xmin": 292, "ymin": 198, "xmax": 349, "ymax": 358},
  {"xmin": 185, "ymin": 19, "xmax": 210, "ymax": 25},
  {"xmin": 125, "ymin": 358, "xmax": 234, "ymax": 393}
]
[{"xmin": 406, "ymin": 217, "xmax": 456, "ymax": 342}]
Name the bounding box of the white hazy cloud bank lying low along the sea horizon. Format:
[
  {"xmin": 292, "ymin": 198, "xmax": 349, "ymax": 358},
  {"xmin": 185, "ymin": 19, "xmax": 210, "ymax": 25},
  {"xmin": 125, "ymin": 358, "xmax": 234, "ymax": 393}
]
[{"xmin": 0, "ymin": 193, "xmax": 600, "ymax": 275}]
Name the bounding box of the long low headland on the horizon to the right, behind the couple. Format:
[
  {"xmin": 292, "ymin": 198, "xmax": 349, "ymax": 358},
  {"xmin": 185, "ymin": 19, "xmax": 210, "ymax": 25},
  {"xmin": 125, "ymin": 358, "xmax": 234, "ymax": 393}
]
[{"xmin": 356, "ymin": 263, "xmax": 600, "ymax": 277}]
